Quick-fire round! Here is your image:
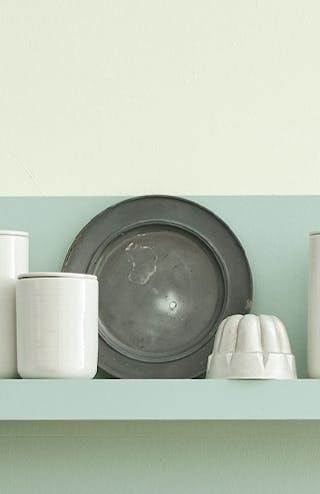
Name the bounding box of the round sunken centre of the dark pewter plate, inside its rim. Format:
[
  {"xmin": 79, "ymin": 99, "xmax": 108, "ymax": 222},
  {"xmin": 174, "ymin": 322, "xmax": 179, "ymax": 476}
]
[{"xmin": 89, "ymin": 224, "xmax": 226, "ymax": 362}]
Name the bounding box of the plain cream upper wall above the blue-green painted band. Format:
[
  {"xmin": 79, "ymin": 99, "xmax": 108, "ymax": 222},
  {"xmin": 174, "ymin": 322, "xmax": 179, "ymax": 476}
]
[{"xmin": 0, "ymin": 0, "xmax": 320, "ymax": 195}]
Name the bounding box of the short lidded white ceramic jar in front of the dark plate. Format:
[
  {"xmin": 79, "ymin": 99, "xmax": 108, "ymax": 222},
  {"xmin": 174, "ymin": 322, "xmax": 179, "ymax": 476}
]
[{"xmin": 17, "ymin": 273, "xmax": 98, "ymax": 379}]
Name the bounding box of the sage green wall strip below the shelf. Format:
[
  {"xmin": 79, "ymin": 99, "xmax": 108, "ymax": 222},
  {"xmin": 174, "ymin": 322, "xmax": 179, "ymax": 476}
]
[{"xmin": 0, "ymin": 422, "xmax": 320, "ymax": 494}]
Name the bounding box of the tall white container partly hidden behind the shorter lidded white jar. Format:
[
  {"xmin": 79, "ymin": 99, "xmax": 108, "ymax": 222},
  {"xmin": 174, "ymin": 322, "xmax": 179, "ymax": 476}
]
[{"xmin": 0, "ymin": 230, "xmax": 29, "ymax": 378}]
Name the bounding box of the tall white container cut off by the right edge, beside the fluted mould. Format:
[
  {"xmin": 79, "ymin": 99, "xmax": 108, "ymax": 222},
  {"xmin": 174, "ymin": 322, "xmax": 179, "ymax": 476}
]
[{"xmin": 308, "ymin": 232, "xmax": 320, "ymax": 378}]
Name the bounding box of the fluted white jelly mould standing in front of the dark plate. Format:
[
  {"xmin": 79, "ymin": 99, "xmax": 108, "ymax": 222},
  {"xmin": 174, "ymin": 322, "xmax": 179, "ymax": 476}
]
[{"xmin": 207, "ymin": 314, "xmax": 297, "ymax": 379}]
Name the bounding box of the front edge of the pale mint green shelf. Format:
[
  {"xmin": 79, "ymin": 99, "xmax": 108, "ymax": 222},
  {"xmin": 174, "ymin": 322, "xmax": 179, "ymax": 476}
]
[{"xmin": 0, "ymin": 379, "xmax": 320, "ymax": 421}]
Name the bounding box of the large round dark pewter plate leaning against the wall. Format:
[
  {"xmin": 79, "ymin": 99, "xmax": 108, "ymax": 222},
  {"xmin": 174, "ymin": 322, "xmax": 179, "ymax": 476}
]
[{"xmin": 63, "ymin": 196, "xmax": 252, "ymax": 378}]
